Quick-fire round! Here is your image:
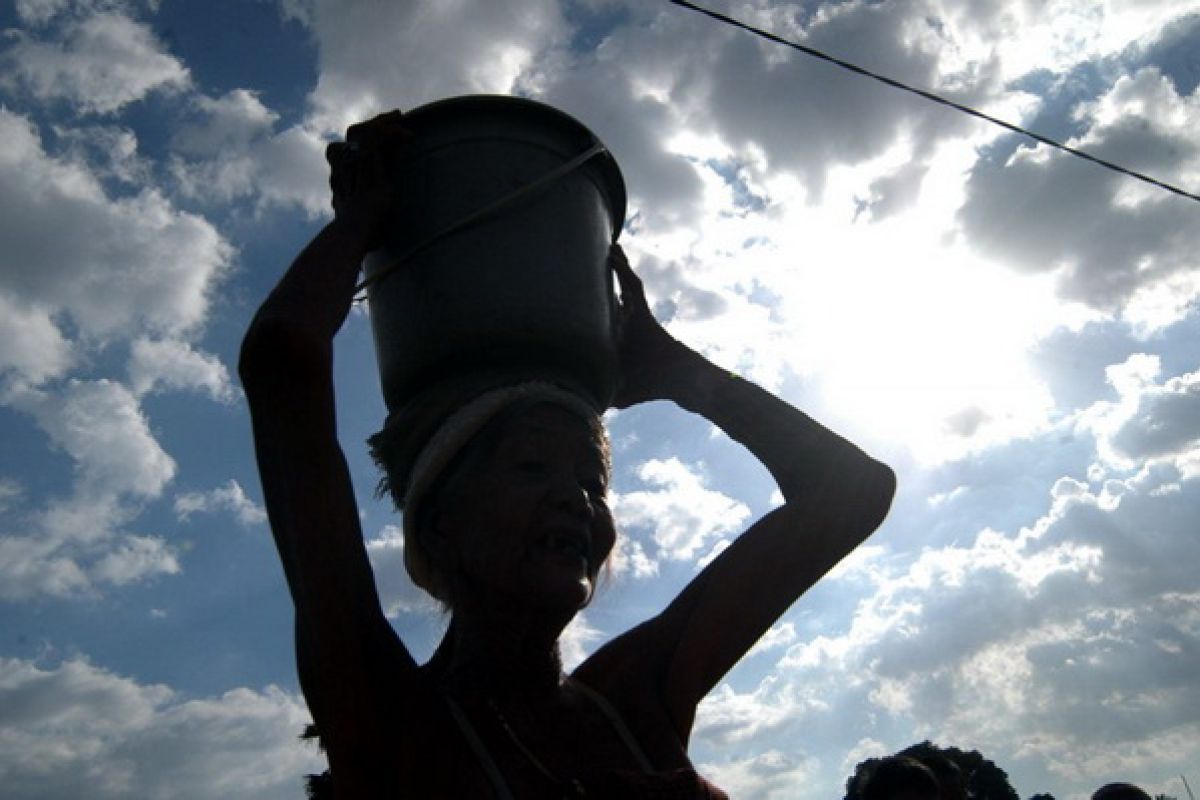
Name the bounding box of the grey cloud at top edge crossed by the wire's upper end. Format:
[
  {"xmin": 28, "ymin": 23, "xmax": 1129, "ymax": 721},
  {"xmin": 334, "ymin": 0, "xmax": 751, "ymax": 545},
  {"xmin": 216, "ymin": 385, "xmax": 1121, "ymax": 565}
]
[{"xmin": 688, "ymin": 4, "xmax": 991, "ymax": 197}]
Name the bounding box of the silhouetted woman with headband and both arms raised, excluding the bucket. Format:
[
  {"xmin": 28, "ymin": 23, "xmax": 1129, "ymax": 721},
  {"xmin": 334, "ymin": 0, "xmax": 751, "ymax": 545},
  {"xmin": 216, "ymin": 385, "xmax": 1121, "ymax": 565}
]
[{"xmin": 240, "ymin": 113, "xmax": 897, "ymax": 800}]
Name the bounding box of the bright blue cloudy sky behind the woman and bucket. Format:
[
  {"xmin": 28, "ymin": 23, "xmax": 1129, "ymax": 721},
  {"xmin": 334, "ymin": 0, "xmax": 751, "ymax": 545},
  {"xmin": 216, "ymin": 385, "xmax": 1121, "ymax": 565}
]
[{"xmin": 0, "ymin": 0, "xmax": 1200, "ymax": 800}]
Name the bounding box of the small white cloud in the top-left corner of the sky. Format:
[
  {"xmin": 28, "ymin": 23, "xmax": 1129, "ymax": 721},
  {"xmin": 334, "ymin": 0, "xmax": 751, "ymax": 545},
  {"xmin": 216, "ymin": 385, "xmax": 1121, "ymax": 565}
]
[{"xmin": 0, "ymin": 5, "xmax": 191, "ymax": 114}]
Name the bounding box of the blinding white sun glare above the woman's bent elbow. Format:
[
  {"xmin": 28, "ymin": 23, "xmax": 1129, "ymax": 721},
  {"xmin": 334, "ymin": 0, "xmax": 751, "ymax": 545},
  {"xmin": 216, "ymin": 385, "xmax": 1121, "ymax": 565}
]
[{"xmin": 779, "ymin": 196, "xmax": 1085, "ymax": 463}]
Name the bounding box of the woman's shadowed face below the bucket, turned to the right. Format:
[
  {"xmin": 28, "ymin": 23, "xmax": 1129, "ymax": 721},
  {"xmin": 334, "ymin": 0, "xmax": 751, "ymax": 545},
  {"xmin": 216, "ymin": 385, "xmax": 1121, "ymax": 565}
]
[{"xmin": 434, "ymin": 404, "xmax": 616, "ymax": 612}]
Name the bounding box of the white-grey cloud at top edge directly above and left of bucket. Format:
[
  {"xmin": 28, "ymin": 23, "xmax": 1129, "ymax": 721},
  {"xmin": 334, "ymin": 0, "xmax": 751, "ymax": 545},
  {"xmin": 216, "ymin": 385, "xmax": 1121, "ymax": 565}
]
[{"xmin": 169, "ymin": 0, "xmax": 566, "ymax": 217}]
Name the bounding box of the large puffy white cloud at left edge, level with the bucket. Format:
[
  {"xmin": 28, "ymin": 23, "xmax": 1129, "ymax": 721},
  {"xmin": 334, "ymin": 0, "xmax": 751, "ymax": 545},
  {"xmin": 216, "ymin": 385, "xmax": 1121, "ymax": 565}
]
[{"xmin": 0, "ymin": 109, "xmax": 232, "ymax": 341}]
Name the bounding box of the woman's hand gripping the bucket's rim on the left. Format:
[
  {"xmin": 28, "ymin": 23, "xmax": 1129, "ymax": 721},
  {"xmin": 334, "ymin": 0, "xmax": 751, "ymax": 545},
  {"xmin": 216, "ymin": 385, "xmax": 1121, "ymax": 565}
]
[{"xmin": 325, "ymin": 110, "xmax": 413, "ymax": 251}]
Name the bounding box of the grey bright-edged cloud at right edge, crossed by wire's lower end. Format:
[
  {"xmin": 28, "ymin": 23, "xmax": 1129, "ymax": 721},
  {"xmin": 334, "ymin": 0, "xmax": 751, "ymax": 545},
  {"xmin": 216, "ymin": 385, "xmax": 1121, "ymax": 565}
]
[{"xmin": 959, "ymin": 70, "xmax": 1200, "ymax": 312}]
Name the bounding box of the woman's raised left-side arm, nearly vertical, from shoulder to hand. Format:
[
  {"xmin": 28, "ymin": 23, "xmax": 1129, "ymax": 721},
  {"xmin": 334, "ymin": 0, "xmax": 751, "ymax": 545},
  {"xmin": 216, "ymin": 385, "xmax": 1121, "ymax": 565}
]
[{"xmin": 239, "ymin": 114, "xmax": 414, "ymax": 778}]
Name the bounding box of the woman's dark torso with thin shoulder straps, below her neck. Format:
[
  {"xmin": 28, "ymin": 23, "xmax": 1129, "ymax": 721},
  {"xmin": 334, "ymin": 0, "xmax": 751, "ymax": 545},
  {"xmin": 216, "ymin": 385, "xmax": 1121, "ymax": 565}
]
[{"xmin": 335, "ymin": 668, "xmax": 725, "ymax": 800}]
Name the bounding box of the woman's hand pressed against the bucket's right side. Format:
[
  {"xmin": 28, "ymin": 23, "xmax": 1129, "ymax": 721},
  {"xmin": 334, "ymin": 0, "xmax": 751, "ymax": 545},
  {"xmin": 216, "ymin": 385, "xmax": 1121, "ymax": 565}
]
[{"xmin": 608, "ymin": 245, "xmax": 700, "ymax": 408}]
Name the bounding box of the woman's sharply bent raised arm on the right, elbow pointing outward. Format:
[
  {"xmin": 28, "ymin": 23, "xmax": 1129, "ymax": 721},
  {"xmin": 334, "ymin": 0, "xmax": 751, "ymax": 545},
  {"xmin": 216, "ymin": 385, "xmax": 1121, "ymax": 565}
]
[{"xmin": 604, "ymin": 248, "xmax": 895, "ymax": 741}]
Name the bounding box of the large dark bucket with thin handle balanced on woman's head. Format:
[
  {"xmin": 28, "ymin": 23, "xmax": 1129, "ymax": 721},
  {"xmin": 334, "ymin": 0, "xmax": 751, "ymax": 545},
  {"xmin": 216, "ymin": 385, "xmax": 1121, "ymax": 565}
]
[{"xmin": 364, "ymin": 95, "xmax": 625, "ymax": 411}]
